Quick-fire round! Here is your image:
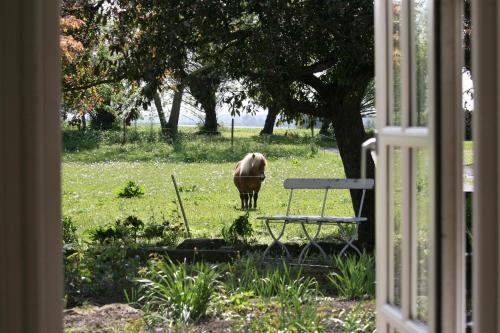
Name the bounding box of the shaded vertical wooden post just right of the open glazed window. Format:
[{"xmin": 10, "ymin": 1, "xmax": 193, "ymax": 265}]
[{"xmin": 437, "ymin": 0, "xmax": 466, "ymax": 333}]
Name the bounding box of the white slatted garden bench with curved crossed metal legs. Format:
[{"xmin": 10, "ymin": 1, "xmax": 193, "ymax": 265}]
[{"xmin": 257, "ymin": 178, "xmax": 374, "ymax": 263}]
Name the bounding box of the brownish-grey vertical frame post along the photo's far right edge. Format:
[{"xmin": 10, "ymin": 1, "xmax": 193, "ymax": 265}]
[{"xmin": 472, "ymin": 0, "xmax": 500, "ymax": 332}]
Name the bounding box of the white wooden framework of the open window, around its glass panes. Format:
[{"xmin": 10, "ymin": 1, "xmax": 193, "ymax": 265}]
[{"xmin": 375, "ymin": 0, "xmax": 438, "ymax": 333}]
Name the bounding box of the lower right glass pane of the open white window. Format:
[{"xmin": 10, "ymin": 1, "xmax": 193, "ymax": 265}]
[{"xmin": 413, "ymin": 149, "xmax": 431, "ymax": 323}]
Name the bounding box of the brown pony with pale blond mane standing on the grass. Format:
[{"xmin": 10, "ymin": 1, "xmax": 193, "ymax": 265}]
[{"xmin": 234, "ymin": 153, "xmax": 267, "ymax": 209}]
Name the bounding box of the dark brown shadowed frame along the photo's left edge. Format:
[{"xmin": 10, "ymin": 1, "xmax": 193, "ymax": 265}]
[{"xmin": 0, "ymin": 0, "xmax": 63, "ymax": 333}]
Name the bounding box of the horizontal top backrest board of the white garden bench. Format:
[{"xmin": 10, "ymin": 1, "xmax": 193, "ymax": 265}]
[{"xmin": 283, "ymin": 178, "xmax": 375, "ymax": 190}]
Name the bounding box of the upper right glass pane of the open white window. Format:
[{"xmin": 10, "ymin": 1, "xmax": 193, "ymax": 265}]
[{"xmin": 412, "ymin": 0, "xmax": 429, "ymax": 126}]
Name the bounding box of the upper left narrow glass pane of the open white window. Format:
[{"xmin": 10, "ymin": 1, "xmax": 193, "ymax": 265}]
[{"xmin": 390, "ymin": 0, "xmax": 401, "ymax": 125}]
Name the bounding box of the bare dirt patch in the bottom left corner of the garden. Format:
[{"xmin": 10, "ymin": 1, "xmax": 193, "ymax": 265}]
[{"xmin": 64, "ymin": 303, "xmax": 141, "ymax": 333}]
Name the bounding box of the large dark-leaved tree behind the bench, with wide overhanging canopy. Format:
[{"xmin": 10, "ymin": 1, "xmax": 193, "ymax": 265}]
[{"xmin": 63, "ymin": 0, "xmax": 375, "ymax": 249}]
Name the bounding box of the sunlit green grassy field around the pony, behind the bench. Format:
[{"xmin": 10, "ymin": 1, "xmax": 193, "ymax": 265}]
[{"xmin": 63, "ymin": 126, "xmax": 352, "ymax": 242}]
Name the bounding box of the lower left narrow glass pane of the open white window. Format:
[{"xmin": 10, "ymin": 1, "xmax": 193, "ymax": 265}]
[{"xmin": 391, "ymin": 147, "xmax": 402, "ymax": 306}]
